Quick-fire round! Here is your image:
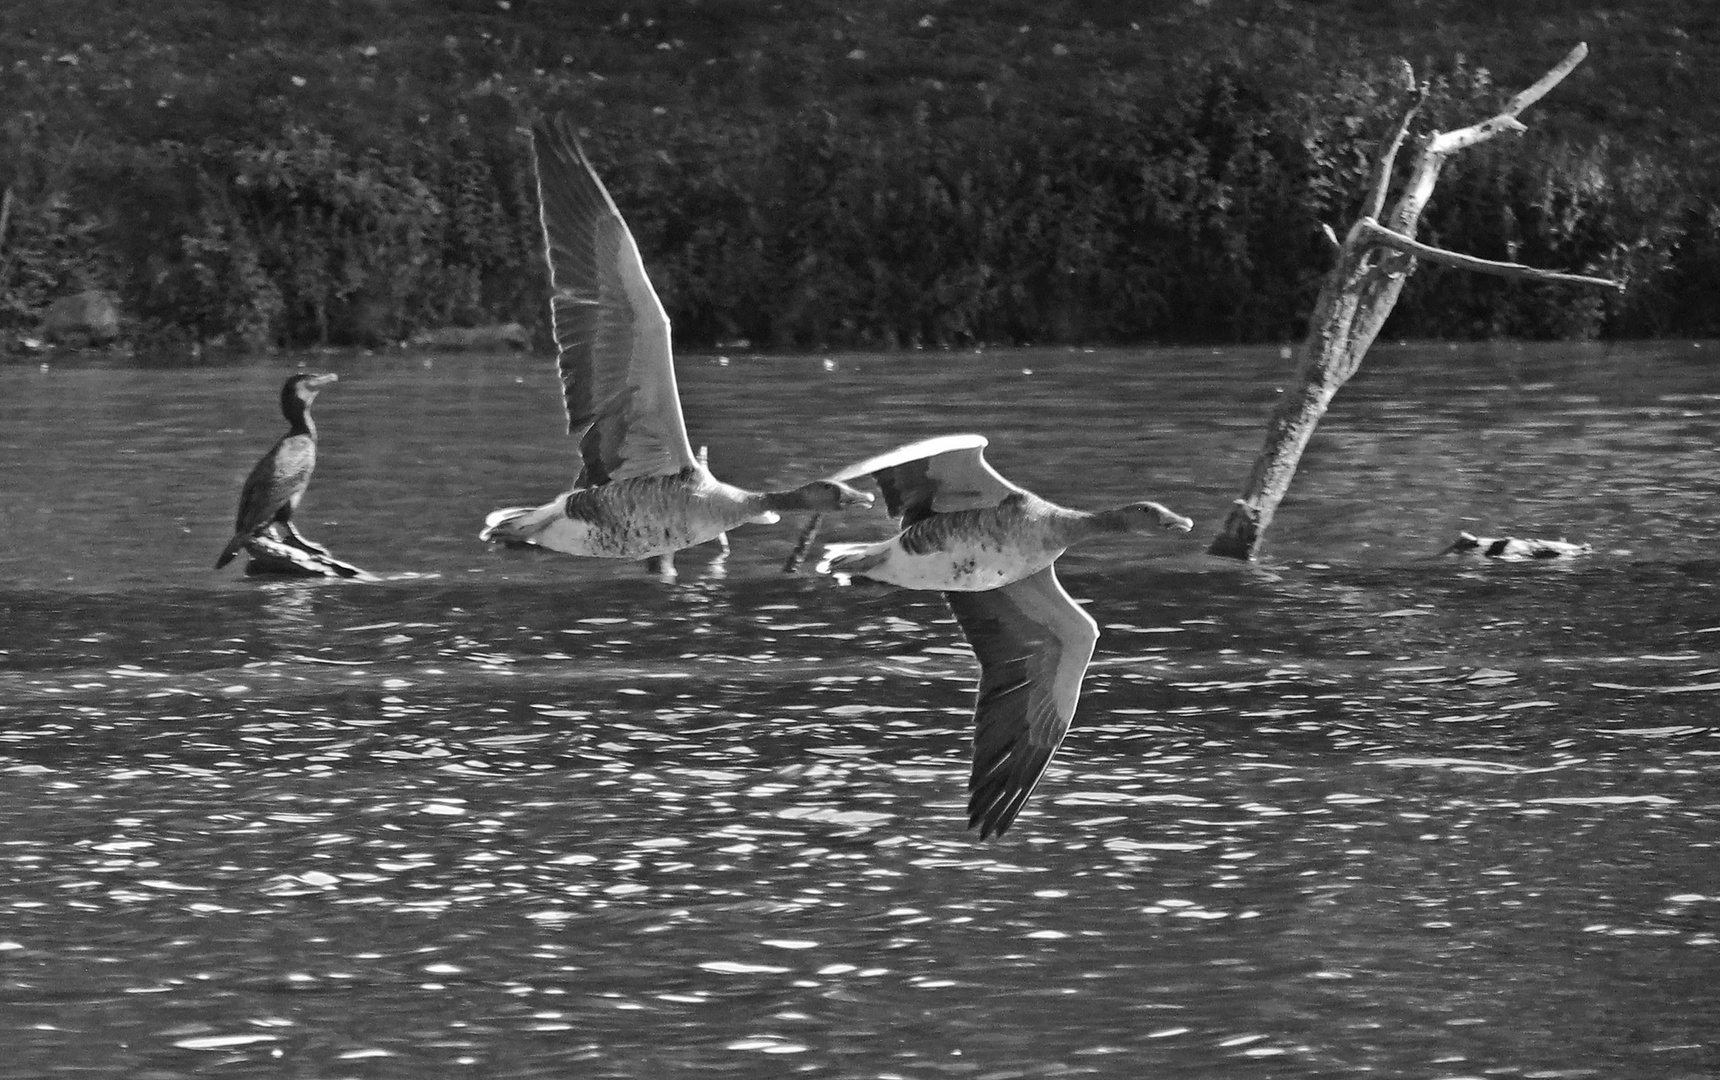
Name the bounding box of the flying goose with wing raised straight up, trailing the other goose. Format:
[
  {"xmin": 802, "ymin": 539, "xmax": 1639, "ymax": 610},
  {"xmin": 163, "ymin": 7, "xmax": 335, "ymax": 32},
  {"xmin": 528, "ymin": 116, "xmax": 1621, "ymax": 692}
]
[{"xmin": 480, "ymin": 120, "xmax": 872, "ymax": 574}]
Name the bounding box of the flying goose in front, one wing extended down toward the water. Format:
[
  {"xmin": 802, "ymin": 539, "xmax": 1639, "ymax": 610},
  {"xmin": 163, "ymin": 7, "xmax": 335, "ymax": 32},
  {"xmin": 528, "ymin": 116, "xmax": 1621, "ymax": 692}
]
[{"xmin": 819, "ymin": 435, "xmax": 1194, "ymax": 839}]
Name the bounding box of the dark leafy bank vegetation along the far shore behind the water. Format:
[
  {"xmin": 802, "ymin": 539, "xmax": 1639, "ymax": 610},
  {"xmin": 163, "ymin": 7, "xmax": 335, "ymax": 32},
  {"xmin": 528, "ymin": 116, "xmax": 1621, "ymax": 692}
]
[{"xmin": 0, "ymin": 0, "xmax": 1720, "ymax": 351}]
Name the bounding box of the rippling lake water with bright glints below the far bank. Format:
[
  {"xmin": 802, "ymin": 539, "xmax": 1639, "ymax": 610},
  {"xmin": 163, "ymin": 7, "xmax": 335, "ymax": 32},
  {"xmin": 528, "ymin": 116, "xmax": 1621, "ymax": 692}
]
[{"xmin": 0, "ymin": 342, "xmax": 1720, "ymax": 1080}]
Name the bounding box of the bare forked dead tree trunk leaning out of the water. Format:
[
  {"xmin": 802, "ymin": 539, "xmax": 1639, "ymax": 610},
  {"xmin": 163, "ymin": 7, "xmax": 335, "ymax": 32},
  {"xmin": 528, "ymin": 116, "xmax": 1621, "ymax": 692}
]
[{"xmin": 1207, "ymin": 45, "xmax": 1624, "ymax": 559}]
